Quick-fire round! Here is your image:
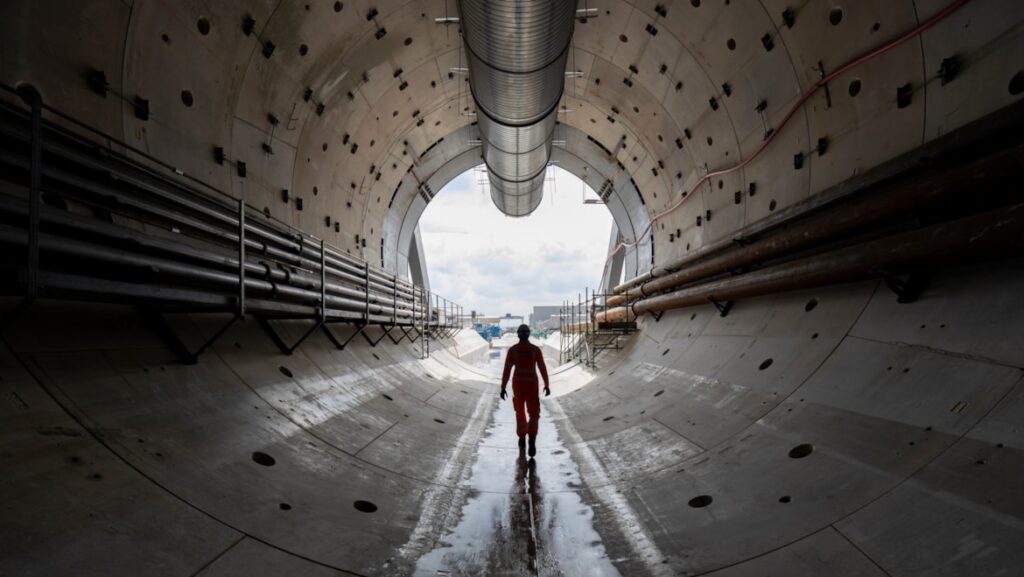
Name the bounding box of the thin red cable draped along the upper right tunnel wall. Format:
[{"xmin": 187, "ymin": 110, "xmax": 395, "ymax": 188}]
[{"xmin": 601, "ymin": 0, "xmax": 971, "ymax": 289}]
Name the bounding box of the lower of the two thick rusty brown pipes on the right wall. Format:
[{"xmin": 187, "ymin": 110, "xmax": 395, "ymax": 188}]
[{"xmin": 599, "ymin": 203, "xmax": 1024, "ymax": 322}]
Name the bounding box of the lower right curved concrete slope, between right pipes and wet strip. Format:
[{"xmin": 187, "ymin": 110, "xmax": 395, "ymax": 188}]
[{"xmin": 558, "ymin": 259, "xmax": 1024, "ymax": 577}]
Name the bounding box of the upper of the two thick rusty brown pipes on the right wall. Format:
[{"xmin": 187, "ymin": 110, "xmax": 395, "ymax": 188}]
[{"xmin": 608, "ymin": 145, "xmax": 1024, "ymax": 306}]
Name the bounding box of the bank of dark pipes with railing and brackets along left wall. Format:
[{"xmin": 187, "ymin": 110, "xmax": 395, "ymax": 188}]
[{"xmin": 0, "ymin": 86, "xmax": 461, "ymax": 362}]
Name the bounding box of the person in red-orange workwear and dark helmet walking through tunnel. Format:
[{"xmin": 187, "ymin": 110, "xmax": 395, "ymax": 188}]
[{"xmin": 502, "ymin": 325, "xmax": 551, "ymax": 457}]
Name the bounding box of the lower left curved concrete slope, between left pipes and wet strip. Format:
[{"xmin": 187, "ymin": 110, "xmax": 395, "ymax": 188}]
[{"xmin": 0, "ymin": 300, "xmax": 495, "ymax": 575}]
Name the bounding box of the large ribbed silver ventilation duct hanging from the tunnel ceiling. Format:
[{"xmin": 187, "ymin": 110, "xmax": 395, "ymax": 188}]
[{"xmin": 459, "ymin": 0, "xmax": 577, "ymax": 216}]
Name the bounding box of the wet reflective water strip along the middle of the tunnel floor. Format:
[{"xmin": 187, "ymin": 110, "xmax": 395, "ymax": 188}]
[{"xmin": 416, "ymin": 350, "xmax": 620, "ymax": 577}]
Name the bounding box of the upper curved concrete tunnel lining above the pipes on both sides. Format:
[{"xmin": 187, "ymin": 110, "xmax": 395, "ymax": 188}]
[{"xmin": 0, "ymin": 0, "xmax": 1024, "ymax": 280}]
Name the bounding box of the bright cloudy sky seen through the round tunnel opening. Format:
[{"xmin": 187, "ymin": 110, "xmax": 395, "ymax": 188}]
[{"xmin": 420, "ymin": 166, "xmax": 611, "ymax": 318}]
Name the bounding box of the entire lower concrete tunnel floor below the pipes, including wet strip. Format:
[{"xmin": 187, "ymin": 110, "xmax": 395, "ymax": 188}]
[{"xmin": 0, "ymin": 260, "xmax": 1024, "ymax": 577}]
